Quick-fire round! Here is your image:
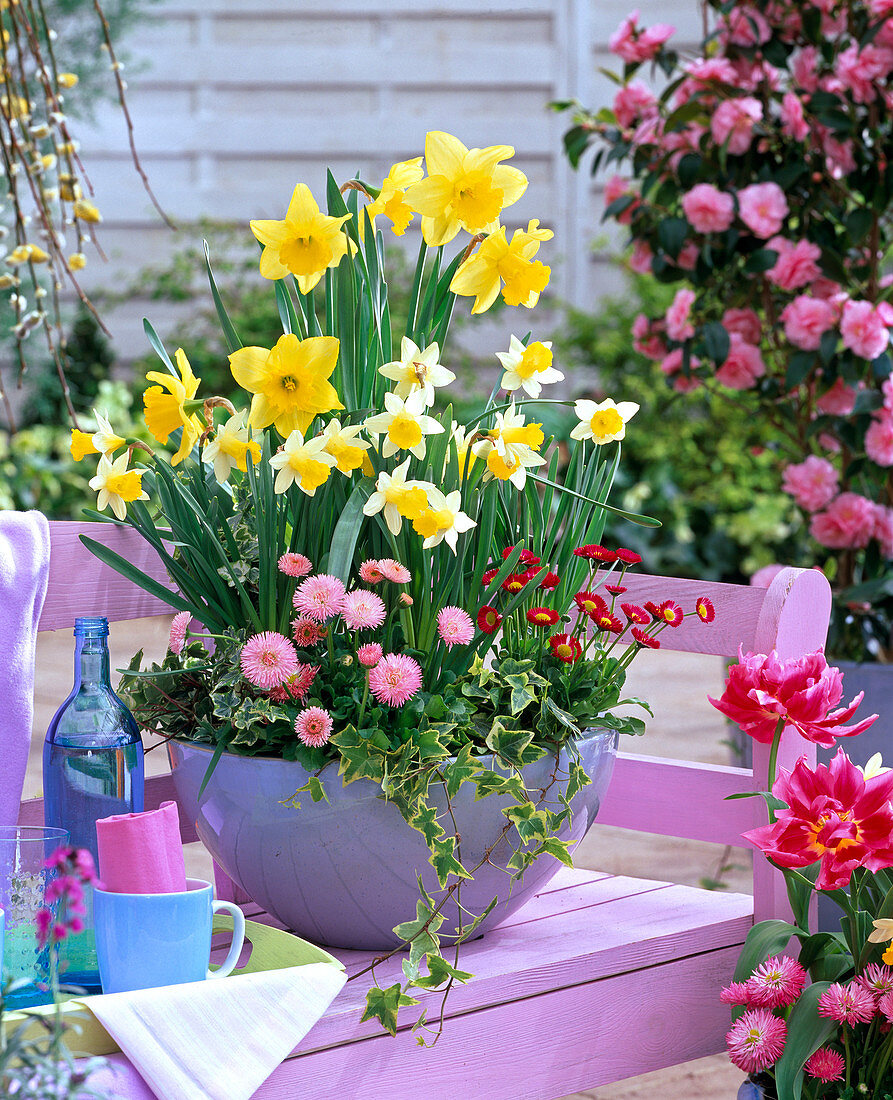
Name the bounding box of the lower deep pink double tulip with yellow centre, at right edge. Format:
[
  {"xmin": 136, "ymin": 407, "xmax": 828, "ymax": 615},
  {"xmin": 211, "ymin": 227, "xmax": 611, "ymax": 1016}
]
[{"xmin": 742, "ymin": 748, "xmax": 893, "ymax": 893}]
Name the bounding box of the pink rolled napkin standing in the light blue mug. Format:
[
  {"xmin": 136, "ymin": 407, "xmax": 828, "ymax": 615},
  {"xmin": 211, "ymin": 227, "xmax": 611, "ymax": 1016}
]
[{"xmin": 96, "ymin": 802, "xmax": 186, "ymax": 893}]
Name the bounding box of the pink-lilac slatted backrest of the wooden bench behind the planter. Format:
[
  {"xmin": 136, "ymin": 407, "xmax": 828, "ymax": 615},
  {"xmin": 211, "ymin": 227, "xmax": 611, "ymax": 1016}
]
[{"xmin": 29, "ymin": 521, "xmax": 831, "ymax": 920}]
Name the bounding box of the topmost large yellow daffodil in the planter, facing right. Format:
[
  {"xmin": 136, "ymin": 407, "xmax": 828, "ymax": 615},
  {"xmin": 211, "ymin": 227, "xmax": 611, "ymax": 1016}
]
[{"xmin": 406, "ymin": 130, "xmax": 527, "ymax": 246}]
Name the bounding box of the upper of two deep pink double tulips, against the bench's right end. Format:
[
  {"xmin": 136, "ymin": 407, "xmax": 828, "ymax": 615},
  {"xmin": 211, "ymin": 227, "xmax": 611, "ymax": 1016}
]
[{"xmin": 708, "ymin": 649, "xmax": 879, "ymax": 748}]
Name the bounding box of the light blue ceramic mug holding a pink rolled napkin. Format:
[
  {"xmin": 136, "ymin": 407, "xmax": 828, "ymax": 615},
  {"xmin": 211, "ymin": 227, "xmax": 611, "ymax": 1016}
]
[{"xmin": 93, "ymin": 879, "xmax": 245, "ymax": 993}]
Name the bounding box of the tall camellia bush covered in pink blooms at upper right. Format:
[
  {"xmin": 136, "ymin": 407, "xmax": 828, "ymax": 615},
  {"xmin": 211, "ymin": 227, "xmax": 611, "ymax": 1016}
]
[{"xmin": 555, "ymin": 0, "xmax": 893, "ymax": 660}]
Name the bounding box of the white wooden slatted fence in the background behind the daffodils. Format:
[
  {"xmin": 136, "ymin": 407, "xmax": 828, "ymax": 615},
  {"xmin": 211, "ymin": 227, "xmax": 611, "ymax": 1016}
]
[{"xmin": 67, "ymin": 0, "xmax": 699, "ymax": 358}]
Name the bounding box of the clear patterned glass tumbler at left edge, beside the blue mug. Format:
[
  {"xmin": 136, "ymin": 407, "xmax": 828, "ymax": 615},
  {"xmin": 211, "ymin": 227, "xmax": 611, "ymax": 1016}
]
[{"xmin": 0, "ymin": 825, "xmax": 68, "ymax": 1009}]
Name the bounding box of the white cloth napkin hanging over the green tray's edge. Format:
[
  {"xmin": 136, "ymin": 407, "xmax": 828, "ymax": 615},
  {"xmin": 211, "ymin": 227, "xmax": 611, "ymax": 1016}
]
[{"xmin": 85, "ymin": 963, "xmax": 348, "ymax": 1100}]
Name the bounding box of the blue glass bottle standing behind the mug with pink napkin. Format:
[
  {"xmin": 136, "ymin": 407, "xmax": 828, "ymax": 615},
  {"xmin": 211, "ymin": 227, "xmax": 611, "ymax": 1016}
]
[{"xmin": 43, "ymin": 616, "xmax": 144, "ymax": 990}]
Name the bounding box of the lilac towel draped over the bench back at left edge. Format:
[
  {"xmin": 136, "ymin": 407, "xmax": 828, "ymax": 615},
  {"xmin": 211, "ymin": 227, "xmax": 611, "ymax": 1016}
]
[{"xmin": 0, "ymin": 512, "xmax": 49, "ymax": 825}]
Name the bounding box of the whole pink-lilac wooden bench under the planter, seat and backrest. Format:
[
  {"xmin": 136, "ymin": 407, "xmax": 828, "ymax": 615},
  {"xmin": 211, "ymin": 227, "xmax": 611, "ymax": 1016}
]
[{"xmin": 21, "ymin": 523, "xmax": 830, "ymax": 1100}]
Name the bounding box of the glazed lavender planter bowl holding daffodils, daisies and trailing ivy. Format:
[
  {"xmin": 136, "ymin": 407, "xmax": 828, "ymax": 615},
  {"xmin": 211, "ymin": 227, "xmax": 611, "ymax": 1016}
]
[{"xmin": 168, "ymin": 729, "xmax": 617, "ymax": 950}]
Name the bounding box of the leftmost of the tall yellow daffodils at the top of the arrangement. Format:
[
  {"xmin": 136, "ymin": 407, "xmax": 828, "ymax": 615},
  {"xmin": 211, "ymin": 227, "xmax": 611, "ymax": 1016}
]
[{"xmin": 251, "ymin": 184, "xmax": 351, "ymax": 294}]
